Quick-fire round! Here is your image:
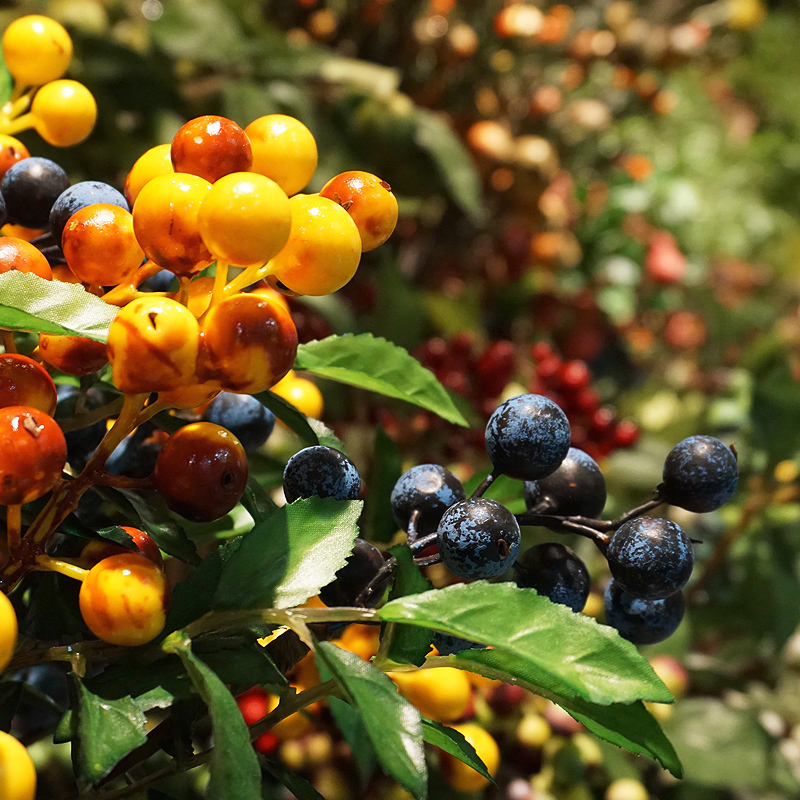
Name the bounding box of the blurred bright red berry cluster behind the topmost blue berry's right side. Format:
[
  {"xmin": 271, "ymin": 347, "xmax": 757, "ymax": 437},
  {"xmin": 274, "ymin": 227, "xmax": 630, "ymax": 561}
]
[{"xmin": 530, "ymin": 342, "xmax": 639, "ymax": 458}]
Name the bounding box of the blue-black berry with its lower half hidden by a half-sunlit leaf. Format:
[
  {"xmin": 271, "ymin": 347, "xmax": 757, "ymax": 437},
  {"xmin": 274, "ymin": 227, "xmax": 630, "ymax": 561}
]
[{"xmin": 283, "ymin": 445, "xmax": 361, "ymax": 503}]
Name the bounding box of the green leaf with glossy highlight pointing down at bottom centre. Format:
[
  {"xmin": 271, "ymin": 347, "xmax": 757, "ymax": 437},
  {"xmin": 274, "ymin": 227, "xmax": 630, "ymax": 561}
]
[{"xmin": 315, "ymin": 642, "xmax": 428, "ymax": 800}]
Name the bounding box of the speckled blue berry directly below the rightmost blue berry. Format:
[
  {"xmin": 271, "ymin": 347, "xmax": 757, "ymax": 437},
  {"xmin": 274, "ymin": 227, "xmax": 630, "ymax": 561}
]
[{"xmin": 606, "ymin": 517, "xmax": 694, "ymax": 600}]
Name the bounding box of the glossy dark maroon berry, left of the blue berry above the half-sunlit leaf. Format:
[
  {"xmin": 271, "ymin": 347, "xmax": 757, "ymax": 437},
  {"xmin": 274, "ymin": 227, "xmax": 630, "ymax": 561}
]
[{"xmin": 153, "ymin": 422, "xmax": 248, "ymax": 522}]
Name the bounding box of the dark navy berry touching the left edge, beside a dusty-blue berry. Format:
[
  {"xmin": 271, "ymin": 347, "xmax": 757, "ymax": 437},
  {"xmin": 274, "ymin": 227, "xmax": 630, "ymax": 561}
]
[{"xmin": 0, "ymin": 156, "xmax": 69, "ymax": 228}]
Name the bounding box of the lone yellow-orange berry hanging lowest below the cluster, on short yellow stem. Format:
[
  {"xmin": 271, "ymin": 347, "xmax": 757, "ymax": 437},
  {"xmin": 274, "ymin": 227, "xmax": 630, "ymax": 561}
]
[{"xmin": 78, "ymin": 553, "xmax": 169, "ymax": 647}]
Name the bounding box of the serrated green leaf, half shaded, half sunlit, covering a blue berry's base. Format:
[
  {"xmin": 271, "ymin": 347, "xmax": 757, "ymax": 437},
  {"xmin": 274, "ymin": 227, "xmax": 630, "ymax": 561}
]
[{"xmin": 214, "ymin": 497, "xmax": 363, "ymax": 608}]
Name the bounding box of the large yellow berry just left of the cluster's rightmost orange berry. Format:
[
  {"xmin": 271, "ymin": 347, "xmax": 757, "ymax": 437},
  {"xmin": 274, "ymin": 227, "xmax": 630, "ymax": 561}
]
[{"xmin": 272, "ymin": 195, "xmax": 361, "ymax": 296}]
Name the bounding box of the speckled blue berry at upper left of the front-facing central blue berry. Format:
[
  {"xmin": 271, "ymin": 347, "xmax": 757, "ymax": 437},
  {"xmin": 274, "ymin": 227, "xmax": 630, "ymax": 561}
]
[{"xmin": 391, "ymin": 464, "xmax": 467, "ymax": 536}]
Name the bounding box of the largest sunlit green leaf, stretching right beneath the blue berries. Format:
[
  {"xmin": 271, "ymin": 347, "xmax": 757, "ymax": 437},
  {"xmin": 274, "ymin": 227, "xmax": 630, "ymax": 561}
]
[{"xmin": 378, "ymin": 581, "xmax": 673, "ymax": 705}]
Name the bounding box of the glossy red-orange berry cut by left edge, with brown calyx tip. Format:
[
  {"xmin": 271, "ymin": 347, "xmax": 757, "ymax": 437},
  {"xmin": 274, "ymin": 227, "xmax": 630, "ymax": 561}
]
[{"xmin": 0, "ymin": 406, "xmax": 67, "ymax": 506}]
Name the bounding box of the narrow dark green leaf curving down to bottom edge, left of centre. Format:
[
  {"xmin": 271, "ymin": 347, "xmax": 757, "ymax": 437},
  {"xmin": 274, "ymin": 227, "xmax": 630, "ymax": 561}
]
[{"xmin": 173, "ymin": 645, "xmax": 261, "ymax": 800}]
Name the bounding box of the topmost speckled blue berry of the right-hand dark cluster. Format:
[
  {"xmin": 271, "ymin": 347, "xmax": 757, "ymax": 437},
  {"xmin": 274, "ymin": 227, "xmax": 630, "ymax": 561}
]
[{"xmin": 486, "ymin": 394, "xmax": 571, "ymax": 481}]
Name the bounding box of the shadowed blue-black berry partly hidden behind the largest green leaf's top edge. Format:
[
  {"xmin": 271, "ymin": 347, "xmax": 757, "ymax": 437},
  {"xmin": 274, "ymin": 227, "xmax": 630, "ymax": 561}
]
[{"xmin": 514, "ymin": 542, "xmax": 591, "ymax": 613}]
